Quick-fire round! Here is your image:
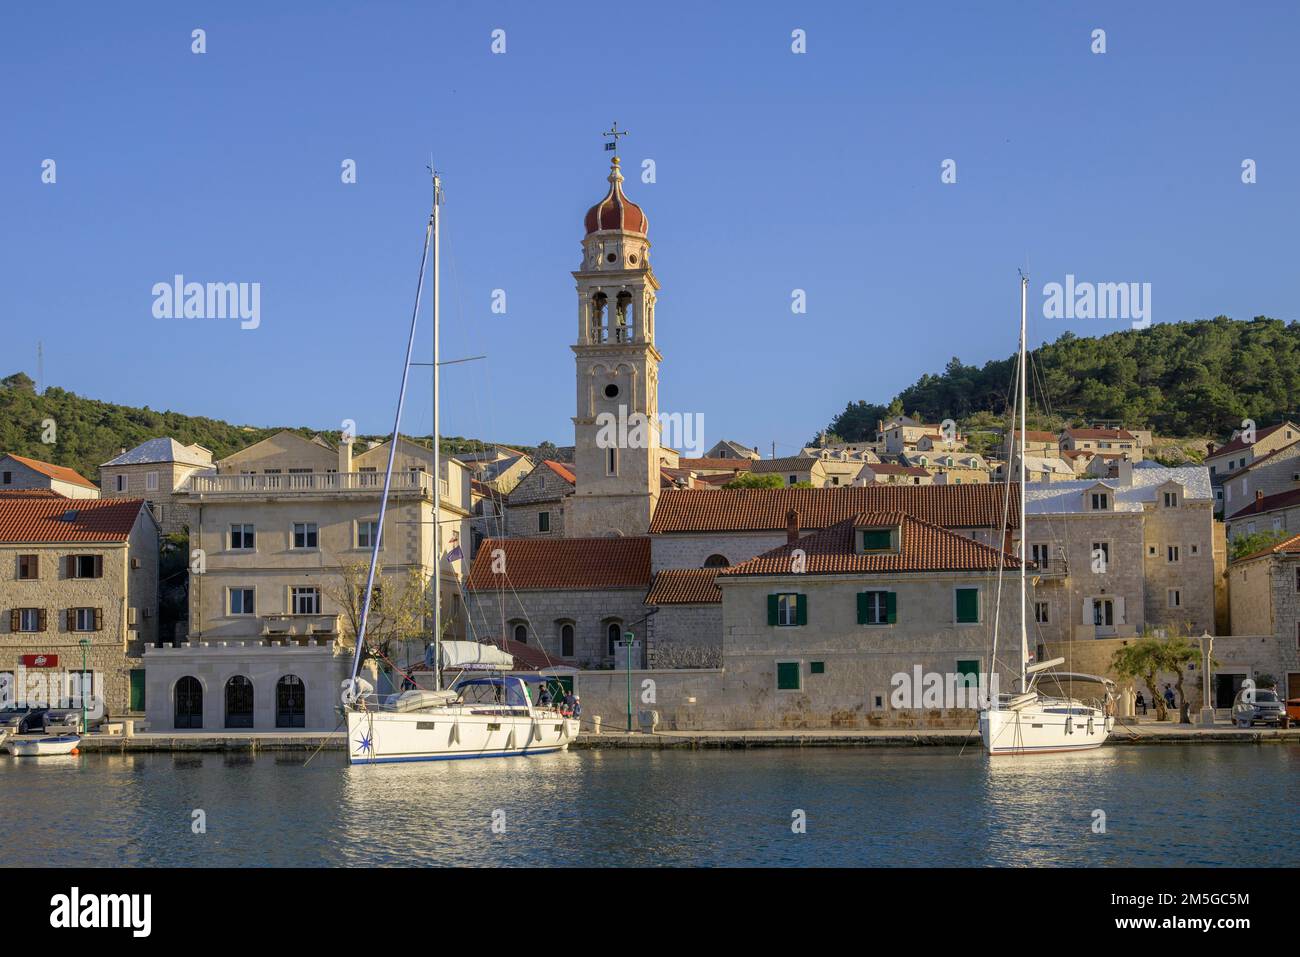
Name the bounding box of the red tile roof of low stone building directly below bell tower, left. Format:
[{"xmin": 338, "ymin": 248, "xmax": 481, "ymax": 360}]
[{"xmin": 465, "ymin": 537, "xmax": 650, "ymax": 592}]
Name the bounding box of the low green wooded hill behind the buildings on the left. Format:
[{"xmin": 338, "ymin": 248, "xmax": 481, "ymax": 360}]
[{"xmin": 0, "ymin": 372, "xmax": 512, "ymax": 481}]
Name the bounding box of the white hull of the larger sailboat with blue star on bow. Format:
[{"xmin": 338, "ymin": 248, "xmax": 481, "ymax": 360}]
[{"xmin": 347, "ymin": 707, "xmax": 579, "ymax": 765}]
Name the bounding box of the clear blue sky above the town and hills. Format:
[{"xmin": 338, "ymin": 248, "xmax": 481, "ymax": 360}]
[{"xmin": 0, "ymin": 3, "xmax": 1300, "ymax": 454}]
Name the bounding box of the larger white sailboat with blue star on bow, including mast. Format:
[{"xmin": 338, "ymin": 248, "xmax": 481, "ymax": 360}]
[{"xmin": 343, "ymin": 167, "xmax": 579, "ymax": 765}]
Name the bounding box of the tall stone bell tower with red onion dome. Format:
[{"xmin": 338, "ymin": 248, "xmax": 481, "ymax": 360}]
[{"xmin": 564, "ymin": 155, "xmax": 663, "ymax": 537}]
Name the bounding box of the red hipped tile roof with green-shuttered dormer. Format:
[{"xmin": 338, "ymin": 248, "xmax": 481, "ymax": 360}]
[{"xmin": 718, "ymin": 511, "xmax": 1019, "ymax": 581}]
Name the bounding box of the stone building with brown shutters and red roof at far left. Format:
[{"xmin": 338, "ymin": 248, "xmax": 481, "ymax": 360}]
[{"xmin": 0, "ymin": 497, "xmax": 159, "ymax": 716}]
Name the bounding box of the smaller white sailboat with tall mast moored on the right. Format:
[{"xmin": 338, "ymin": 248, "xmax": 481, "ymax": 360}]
[{"xmin": 979, "ymin": 273, "xmax": 1114, "ymax": 755}]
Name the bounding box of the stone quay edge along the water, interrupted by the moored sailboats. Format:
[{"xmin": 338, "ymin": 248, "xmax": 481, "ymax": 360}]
[{"xmin": 25, "ymin": 719, "xmax": 1300, "ymax": 752}]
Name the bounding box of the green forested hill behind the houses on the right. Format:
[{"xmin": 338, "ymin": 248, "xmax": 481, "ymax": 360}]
[{"xmin": 827, "ymin": 316, "xmax": 1300, "ymax": 441}]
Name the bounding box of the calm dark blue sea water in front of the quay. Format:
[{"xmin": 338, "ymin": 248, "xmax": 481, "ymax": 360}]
[{"xmin": 0, "ymin": 745, "xmax": 1300, "ymax": 867}]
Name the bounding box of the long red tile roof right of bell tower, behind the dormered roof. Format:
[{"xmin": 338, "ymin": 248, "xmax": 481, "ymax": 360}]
[{"xmin": 650, "ymin": 484, "xmax": 1021, "ymax": 534}]
